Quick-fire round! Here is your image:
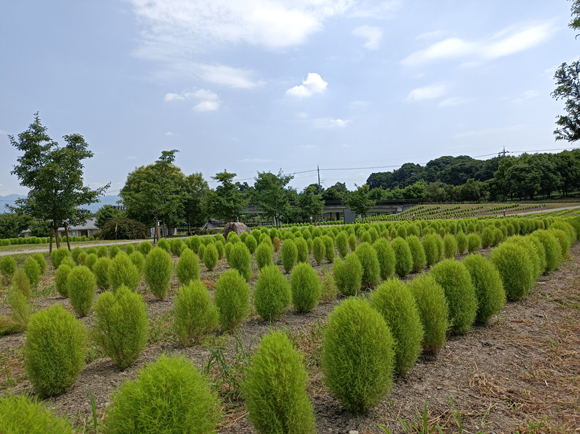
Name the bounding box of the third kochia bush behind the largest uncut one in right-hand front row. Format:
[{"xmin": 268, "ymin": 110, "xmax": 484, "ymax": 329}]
[{"xmin": 431, "ymin": 259, "xmax": 477, "ymax": 334}]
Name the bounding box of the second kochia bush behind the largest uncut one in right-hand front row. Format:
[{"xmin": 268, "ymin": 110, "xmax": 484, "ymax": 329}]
[{"xmin": 407, "ymin": 273, "xmax": 449, "ymax": 355}]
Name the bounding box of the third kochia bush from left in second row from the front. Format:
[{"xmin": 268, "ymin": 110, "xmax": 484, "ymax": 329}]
[{"xmin": 173, "ymin": 280, "xmax": 218, "ymax": 347}]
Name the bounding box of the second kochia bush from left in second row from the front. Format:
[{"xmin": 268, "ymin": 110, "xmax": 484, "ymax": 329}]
[{"xmin": 91, "ymin": 286, "xmax": 149, "ymax": 369}]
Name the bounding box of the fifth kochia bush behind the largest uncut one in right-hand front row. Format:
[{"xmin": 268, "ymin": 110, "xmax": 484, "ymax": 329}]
[{"xmin": 490, "ymin": 243, "xmax": 534, "ymax": 301}]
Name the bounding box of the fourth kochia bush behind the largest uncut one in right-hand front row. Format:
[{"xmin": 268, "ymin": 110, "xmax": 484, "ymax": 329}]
[{"xmin": 463, "ymin": 255, "xmax": 506, "ymax": 324}]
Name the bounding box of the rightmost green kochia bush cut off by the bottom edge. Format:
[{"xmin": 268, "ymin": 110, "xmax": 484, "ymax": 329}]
[{"xmin": 245, "ymin": 331, "xmax": 316, "ymax": 434}]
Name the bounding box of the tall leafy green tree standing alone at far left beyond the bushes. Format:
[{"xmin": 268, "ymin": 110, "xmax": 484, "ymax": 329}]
[{"xmin": 9, "ymin": 113, "xmax": 110, "ymax": 251}]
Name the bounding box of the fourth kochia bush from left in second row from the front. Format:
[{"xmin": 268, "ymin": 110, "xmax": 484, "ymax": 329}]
[{"xmin": 215, "ymin": 270, "xmax": 250, "ymax": 330}]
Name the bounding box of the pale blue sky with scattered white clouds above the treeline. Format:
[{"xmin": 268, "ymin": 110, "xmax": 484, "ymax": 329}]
[{"xmin": 0, "ymin": 0, "xmax": 580, "ymax": 195}]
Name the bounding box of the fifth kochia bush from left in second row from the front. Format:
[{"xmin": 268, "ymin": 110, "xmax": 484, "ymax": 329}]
[{"xmin": 254, "ymin": 265, "xmax": 292, "ymax": 321}]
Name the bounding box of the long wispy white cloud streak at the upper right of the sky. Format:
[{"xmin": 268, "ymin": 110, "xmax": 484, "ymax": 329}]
[{"xmin": 402, "ymin": 22, "xmax": 554, "ymax": 66}]
